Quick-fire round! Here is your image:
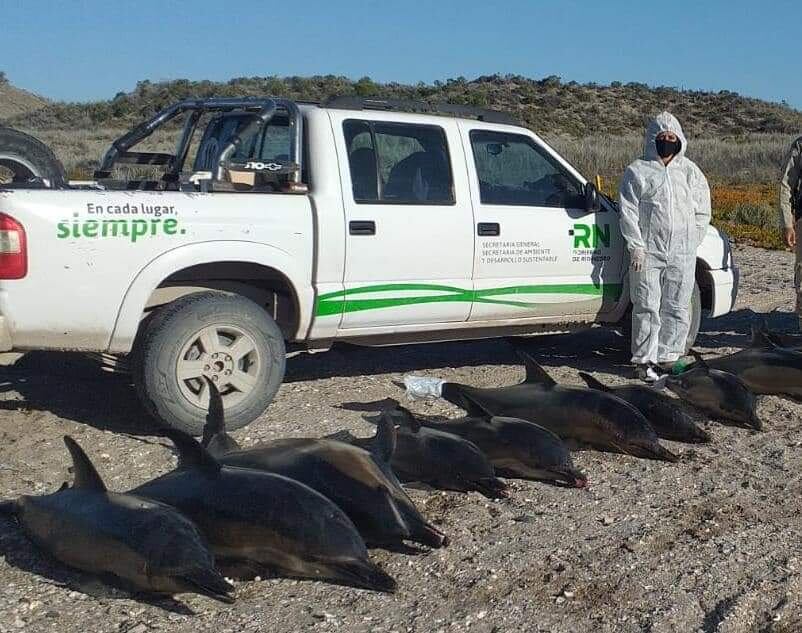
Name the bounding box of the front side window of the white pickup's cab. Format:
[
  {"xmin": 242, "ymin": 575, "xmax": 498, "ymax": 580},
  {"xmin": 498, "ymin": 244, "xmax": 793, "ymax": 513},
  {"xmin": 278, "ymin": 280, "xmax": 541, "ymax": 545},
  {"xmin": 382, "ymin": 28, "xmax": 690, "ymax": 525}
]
[{"xmin": 470, "ymin": 130, "xmax": 585, "ymax": 209}]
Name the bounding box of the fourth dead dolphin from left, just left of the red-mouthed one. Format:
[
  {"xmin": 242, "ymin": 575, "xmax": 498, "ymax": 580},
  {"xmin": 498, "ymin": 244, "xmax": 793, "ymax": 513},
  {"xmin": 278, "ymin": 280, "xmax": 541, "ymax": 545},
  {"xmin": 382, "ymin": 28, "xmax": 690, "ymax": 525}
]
[{"xmin": 342, "ymin": 401, "xmax": 507, "ymax": 499}]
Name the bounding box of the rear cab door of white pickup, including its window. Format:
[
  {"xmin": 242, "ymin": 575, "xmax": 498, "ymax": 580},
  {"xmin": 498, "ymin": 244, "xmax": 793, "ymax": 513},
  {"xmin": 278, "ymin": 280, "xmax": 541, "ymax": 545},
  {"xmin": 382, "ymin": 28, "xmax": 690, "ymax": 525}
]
[{"xmin": 321, "ymin": 112, "xmax": 474, "ymax": 329}]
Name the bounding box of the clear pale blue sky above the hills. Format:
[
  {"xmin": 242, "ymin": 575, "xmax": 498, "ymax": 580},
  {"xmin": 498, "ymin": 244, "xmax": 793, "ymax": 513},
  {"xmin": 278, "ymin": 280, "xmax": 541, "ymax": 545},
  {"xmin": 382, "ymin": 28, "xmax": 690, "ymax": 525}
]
[{"xmin": 0, "ymin": 0, "xmax": 802, "ymax": 109}]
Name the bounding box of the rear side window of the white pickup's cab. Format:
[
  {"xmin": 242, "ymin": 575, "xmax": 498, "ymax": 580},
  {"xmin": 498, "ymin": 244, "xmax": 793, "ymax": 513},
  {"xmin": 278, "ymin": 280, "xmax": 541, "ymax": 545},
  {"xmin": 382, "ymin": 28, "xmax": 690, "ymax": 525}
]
[{"xmin": 343, "ymin": 120, "xmax": 454, "ymax": 204}]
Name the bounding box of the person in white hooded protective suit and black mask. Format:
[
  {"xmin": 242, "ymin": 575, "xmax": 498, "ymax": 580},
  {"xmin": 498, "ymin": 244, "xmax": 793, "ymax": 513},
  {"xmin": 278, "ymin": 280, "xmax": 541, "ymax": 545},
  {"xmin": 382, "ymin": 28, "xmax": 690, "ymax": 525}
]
[{"xmin": 619, "ymin": 112, "xmax": 710, "ymax": 381}]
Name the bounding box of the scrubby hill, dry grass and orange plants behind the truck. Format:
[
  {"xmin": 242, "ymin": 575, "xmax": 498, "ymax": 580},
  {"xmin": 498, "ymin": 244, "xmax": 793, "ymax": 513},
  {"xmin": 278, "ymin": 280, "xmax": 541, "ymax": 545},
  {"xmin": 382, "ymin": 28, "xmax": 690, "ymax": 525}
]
[{"xmin": 0, "ymin": 72, "xmax": 802, "ymax": 248}]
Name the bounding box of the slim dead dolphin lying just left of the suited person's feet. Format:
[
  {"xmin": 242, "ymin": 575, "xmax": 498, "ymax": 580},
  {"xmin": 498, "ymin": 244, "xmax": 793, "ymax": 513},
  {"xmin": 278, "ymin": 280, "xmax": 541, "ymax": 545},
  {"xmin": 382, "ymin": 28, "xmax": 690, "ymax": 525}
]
[{"xmin": 579, "ymin": 371, "xmax": 710, "ymax": 444}]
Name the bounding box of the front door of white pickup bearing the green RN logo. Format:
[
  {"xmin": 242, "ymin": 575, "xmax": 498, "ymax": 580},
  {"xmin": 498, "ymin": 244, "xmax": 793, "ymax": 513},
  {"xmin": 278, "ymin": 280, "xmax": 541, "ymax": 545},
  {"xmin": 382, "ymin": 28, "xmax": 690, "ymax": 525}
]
[{"xmin": 460, "ymin": 122, "xmax": 623, "ymax": 322}]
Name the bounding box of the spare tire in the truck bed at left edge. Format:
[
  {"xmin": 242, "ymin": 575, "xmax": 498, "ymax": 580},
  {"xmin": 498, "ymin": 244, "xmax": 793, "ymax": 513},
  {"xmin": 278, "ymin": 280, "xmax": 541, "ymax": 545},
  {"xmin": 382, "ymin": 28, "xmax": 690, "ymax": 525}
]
[{"xmin": 0, "ymin": 127, "xmax": 67, "ymax": 188}]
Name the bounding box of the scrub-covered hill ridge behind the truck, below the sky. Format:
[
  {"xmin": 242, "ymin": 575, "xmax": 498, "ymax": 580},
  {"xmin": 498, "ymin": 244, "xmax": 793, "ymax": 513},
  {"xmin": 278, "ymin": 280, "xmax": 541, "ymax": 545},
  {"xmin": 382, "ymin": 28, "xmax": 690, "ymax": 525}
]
[{"xmin": 0, "ymin": 75, "xmax": 802, "ymax": 137}]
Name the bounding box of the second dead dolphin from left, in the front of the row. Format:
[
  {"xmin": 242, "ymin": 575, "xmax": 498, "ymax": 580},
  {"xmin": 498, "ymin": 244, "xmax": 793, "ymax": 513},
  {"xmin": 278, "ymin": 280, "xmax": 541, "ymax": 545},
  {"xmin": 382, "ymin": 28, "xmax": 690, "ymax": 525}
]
[{"xmin": 132, "ymin": 429, "xmax": 395, "ymax": 592}]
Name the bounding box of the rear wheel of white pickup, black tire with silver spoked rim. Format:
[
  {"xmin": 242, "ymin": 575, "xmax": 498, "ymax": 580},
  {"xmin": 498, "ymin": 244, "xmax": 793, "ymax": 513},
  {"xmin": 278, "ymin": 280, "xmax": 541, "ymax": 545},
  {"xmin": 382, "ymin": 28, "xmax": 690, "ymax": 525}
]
[{"xmin": 133, "ymin": 292, "xmax": 286, "ymax": 435}]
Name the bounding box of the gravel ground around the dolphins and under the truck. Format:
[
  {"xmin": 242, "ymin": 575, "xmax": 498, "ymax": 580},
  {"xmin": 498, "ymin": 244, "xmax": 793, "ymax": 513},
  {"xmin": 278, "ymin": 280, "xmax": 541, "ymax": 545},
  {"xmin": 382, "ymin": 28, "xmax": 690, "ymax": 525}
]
[{"xmin": 0, "ymin": 247, "xmax": 802, "ymax": 633}]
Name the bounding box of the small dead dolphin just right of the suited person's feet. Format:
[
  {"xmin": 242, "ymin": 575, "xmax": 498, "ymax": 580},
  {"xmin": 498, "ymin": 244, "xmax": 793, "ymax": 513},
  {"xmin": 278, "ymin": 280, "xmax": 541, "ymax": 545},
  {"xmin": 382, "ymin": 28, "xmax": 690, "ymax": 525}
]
[{"xmin": 660, "ymin": 350, "xmax": 763, "ymax": 430}]
